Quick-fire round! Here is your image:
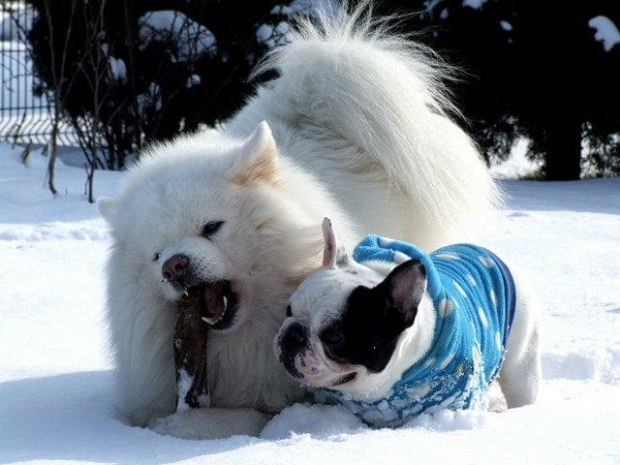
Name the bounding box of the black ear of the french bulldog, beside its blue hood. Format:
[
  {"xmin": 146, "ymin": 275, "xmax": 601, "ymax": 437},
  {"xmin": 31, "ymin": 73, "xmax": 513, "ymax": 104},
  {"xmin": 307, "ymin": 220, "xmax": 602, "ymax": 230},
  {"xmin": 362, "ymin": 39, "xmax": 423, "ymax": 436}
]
[{"xmin": 379, "ymin": 260, "xmax": 426, "ymax": 327}]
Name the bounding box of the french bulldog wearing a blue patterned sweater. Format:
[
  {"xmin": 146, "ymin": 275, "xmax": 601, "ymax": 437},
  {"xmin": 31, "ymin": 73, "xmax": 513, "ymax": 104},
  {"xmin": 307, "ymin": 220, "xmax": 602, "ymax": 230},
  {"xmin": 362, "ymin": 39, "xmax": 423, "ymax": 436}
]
[{"xmin": 274, "ymin": 218, "xmax": 541, "ymax": 427}]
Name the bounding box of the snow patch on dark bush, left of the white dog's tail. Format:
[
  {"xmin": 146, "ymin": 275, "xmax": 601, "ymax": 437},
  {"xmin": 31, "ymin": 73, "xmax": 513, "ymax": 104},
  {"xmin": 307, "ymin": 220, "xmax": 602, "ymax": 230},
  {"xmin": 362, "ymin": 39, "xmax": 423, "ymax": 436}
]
[{"xmin": 138, "ymin": 10, "xmax": 216, "ymax": 61}]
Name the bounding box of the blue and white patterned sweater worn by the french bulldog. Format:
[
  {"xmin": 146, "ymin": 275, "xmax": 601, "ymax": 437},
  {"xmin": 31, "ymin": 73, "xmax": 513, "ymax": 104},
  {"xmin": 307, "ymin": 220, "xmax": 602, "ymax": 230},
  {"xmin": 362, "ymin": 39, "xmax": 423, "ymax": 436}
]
[{"xmin": 317, "ymin": 235, "xmax": 515, "ymax": 427}]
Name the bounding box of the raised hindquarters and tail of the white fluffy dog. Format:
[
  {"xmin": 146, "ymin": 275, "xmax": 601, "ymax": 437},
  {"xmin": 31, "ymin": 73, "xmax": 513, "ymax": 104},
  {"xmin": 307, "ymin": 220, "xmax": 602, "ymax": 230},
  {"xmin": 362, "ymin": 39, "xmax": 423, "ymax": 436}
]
[{"xmin": 226, "ymin": 8, "xmax": 499, "ymax": 249}]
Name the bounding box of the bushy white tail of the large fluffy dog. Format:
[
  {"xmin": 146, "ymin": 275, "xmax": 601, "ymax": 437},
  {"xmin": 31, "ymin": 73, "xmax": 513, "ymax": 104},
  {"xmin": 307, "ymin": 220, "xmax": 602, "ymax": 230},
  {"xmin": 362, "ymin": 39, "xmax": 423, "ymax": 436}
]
[{"xmin": 252, "ymin": 5, "xmax": 500, "ymax": 241}]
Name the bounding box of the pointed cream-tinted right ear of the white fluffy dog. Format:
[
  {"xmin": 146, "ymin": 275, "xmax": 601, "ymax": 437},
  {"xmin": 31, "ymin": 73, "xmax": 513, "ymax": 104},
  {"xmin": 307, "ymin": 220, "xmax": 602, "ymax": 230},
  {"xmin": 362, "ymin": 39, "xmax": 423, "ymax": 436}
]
[{"xmin": 235, "ymin": 121, "xmax": 278, "ymax": 185}]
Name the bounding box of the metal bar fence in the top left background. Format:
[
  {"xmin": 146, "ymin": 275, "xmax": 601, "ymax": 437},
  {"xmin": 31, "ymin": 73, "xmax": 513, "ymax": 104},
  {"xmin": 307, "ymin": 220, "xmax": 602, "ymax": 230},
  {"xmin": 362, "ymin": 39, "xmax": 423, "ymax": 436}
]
[{"xmin": 0, "ymin": 0, "xmax": 76, "ymax": 145}]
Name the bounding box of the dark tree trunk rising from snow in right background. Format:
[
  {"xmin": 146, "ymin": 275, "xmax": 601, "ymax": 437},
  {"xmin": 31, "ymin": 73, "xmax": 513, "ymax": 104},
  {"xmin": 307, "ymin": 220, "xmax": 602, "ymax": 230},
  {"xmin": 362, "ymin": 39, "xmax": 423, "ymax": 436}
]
[{"xmin": 545, "ymin": 111, "xmax": 581, "ymax": 181}]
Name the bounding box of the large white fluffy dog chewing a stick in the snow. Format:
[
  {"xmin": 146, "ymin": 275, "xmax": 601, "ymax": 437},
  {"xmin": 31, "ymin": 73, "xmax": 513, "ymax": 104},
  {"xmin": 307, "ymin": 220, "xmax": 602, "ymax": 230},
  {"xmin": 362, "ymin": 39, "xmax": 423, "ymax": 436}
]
[{"xmin": 99, "ymin": 5, "xmax": 498, "ymax": 437}]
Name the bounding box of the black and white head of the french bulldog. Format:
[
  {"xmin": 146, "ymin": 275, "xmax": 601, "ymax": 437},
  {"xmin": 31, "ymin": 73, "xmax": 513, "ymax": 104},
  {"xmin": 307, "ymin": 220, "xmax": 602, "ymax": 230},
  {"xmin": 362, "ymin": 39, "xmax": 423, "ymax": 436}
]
[{"xmin": 274, "ymin": 218, "xmax": 426, "ymax": 390}]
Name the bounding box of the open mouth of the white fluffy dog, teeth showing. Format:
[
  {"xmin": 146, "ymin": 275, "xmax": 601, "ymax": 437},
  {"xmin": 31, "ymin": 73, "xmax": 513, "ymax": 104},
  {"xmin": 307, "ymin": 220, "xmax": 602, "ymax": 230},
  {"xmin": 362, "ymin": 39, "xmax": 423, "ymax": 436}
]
[{"xmin": 182, "ymin": 280, "xmax": 239, "ymax": 330}]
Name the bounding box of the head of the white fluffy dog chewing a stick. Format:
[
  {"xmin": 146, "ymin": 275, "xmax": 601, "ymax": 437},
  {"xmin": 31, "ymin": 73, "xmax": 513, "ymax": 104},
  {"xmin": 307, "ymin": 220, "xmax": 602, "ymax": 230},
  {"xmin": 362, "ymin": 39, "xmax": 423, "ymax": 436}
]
[{"xmin": 99, "ymin": 124, "xmax": 294, "ymax": 331}]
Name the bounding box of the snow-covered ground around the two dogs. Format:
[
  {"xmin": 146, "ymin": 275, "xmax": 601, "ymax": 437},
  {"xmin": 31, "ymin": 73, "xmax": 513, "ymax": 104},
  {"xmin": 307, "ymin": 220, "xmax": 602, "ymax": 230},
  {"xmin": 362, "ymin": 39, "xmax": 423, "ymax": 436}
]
[{"xmin": 0, "ymin": 145, "xmax": 620, "ymax": 465}]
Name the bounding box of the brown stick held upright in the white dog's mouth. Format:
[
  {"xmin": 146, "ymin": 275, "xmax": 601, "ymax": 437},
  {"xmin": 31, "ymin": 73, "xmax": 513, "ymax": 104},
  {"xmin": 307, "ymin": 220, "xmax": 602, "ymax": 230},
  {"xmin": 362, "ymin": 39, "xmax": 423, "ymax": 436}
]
[{"xmin": 174, "ymin": 295, "xmax": 209, "ymax": 410}]
